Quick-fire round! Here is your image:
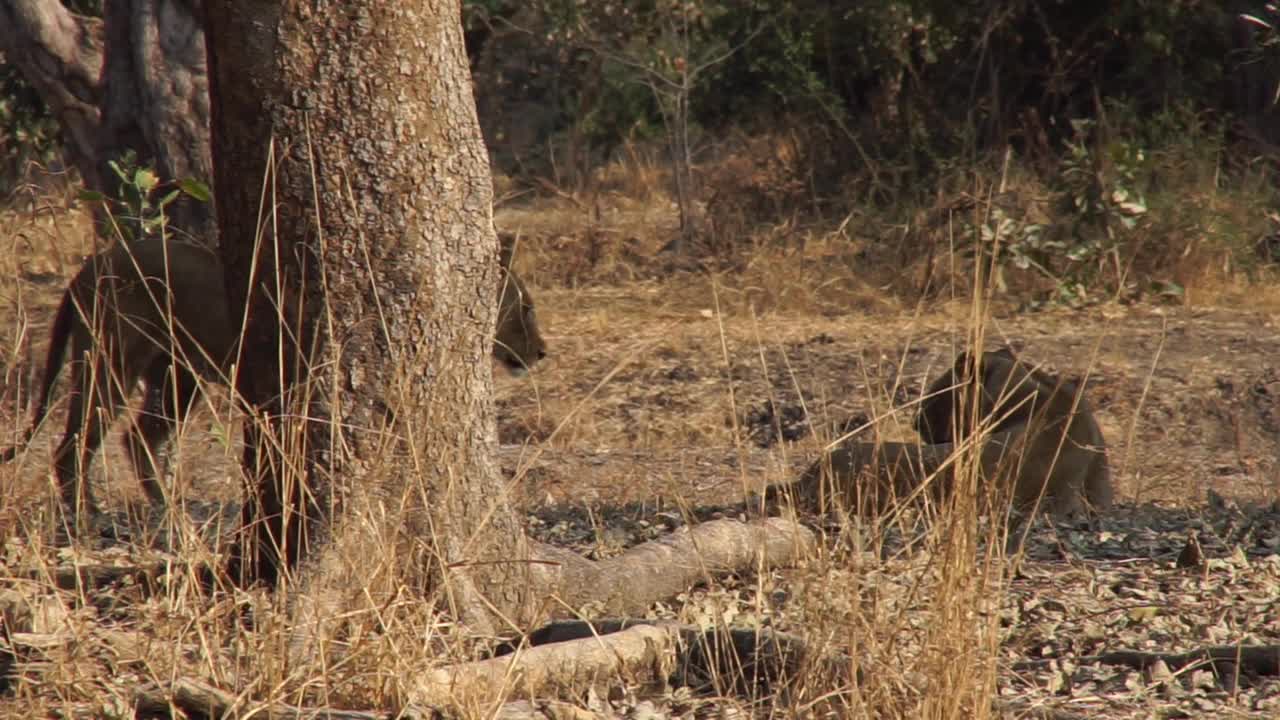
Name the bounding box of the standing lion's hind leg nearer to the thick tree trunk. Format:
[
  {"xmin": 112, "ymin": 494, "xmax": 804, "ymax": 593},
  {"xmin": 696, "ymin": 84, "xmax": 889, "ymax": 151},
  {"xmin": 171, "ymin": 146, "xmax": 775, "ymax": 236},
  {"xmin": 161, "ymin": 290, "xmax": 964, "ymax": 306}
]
[{"xmin": 125, "ymin": 355, "xmax": 196, "ymax": 507}]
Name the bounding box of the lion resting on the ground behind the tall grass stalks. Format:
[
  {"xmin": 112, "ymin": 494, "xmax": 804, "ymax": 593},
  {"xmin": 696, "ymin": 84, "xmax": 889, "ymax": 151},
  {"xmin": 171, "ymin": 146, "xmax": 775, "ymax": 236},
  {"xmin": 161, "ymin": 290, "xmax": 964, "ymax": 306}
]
[{"xmin": 765, "ymin": 350, "xmax": 1112, "ymax": 518}]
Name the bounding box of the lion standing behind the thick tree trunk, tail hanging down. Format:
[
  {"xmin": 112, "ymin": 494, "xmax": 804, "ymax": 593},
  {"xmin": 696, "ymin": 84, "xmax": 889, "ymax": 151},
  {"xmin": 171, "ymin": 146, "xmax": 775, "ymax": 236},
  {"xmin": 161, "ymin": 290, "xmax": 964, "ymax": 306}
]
[{"xmin": 0, "ymin": 238, "xmax": 547, "ymax": 519}]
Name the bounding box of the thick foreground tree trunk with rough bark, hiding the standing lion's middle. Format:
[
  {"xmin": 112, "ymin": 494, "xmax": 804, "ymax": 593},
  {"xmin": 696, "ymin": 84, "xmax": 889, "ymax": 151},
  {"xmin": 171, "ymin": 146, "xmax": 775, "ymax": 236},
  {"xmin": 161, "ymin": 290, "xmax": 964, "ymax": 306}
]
[{"xmin": 206, "ymin": 0, "xmax": 527, "ymax": 618}]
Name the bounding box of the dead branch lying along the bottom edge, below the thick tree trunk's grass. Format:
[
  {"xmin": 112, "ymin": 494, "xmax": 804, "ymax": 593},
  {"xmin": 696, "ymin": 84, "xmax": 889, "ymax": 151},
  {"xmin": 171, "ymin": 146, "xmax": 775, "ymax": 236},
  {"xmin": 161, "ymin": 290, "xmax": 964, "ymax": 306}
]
[{"xmin": 133, "ymin": 678, "xmax": 430, "ymax": 720}]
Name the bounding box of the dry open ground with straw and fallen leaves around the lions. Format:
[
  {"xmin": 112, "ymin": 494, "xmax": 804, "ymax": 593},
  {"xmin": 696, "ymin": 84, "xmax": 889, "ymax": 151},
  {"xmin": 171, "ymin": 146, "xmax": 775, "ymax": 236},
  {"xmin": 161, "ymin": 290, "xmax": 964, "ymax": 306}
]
[{"xmin": 0, "ymin": 194, "xmax": 1280, "ymax": 717}]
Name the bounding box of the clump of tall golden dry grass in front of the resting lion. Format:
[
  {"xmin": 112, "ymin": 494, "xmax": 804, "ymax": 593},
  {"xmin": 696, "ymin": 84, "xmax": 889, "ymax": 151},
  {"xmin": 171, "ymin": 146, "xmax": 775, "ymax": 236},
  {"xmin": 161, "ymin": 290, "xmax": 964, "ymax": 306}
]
[{"xmin": 752, "ymin": 190, "xmax": 1015, "ymax": 719}]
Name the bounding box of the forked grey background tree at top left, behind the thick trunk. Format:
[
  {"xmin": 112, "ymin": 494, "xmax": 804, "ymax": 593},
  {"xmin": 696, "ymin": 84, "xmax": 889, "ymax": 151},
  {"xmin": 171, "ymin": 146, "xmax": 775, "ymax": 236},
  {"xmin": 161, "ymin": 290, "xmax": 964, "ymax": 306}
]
[{"xmin": 0, "ymin": 0, "xmax": 214, "ymax": 245}]
